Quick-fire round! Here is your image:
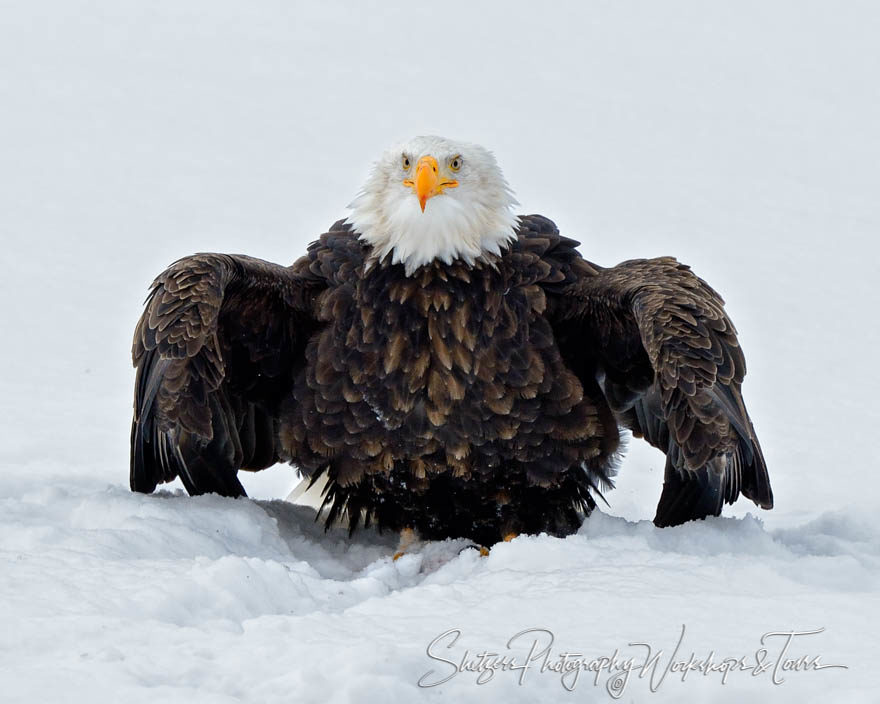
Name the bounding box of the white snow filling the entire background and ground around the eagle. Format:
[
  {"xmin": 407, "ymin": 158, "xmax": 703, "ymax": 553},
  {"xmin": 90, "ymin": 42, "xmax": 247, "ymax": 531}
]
[{"xmin": 0, "ymin": 0, "xmax": 880, "ymax": 704}]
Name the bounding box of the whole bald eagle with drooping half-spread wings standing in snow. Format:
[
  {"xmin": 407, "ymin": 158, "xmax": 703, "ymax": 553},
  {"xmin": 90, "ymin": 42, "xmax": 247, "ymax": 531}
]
[{"xmin": 130, "ymin": 137, "xmax": 773, "ymax": 545}]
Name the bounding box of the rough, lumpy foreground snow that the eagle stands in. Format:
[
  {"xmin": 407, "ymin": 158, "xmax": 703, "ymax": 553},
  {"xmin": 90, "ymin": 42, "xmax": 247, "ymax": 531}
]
[{"xmin": 0, "ymin": 477, "xmax": 880, "ymax": 702}]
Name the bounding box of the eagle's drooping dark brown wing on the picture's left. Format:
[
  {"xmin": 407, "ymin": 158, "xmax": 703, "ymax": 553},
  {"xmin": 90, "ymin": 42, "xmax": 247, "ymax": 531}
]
[{"xmin": 130, "ymin": 254, "xmax": 321, "ymax": 496}]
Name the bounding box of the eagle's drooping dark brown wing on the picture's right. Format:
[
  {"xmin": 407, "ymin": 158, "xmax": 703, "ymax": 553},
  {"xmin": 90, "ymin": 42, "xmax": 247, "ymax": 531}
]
[{"xmin": 532, "ymin": 221, "xmax": 773, "ymax": 526}]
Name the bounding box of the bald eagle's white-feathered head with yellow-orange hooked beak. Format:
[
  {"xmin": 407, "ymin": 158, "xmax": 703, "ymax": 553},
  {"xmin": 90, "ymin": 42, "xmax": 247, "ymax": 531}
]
[{"xmin": 348, "ymin": 137, "xmax": 517, "ymax": 276}]
